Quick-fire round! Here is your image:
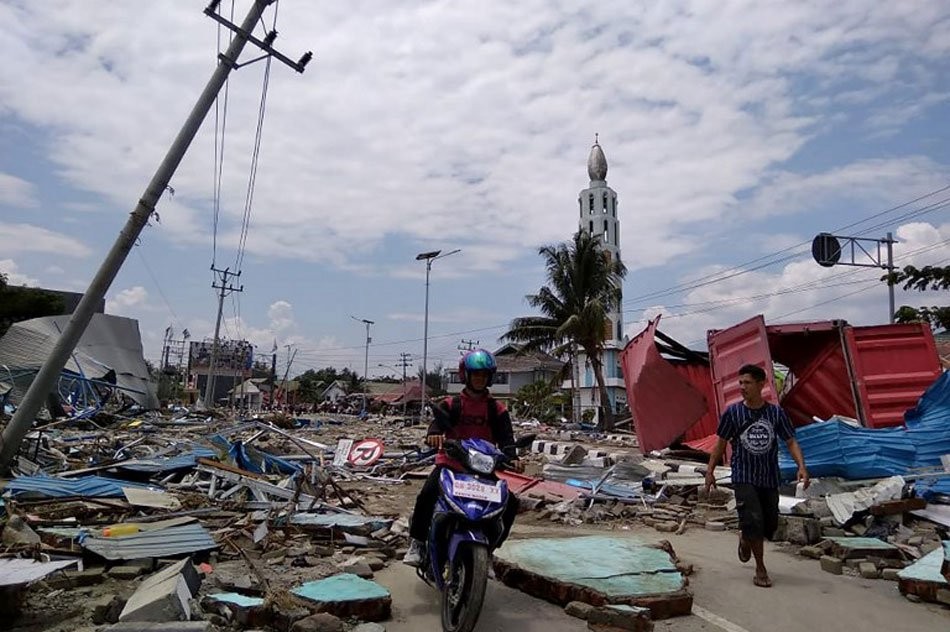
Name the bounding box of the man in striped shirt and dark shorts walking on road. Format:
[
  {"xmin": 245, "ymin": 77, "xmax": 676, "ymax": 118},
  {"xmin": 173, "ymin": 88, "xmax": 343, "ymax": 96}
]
[{"xmin": 706, "ymin": 364, "xmax": 810, "ymax": 588}]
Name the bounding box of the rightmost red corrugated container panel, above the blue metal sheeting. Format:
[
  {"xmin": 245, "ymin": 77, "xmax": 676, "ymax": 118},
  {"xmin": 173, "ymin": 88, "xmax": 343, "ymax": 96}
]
[{"xmin": 846, "ymin": 323, "xmax": 943, "ymax": 428}]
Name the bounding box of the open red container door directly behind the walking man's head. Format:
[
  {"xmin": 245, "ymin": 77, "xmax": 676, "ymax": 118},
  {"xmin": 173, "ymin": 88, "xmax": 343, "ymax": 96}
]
[{"xmin": 707, "ymin": 315, "xmax": 778, "ymax": 416}]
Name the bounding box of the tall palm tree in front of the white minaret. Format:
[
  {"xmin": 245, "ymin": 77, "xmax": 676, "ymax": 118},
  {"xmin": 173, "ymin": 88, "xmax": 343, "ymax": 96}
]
[{"xmin": 502, "ymin": 230, "xmax": 627, "ymax": 430}]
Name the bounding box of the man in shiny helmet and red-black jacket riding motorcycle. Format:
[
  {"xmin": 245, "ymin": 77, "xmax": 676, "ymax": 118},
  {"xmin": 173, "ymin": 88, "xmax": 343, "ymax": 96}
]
[{"xmin": 403, "ymin": 349, "xmax": 521, "ymax": 566}]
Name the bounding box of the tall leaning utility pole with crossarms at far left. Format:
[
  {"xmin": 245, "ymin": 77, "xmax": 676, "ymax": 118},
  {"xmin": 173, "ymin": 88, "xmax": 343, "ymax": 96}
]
[{"xmin": 0, "ymin": 0, "xmax": 313, "ymax": 470}]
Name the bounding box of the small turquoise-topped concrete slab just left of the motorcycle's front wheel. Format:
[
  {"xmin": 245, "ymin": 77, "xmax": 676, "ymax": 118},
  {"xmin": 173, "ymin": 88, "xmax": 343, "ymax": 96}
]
[{"xmin": 291, "ymin": 573, "xmax": 392, "ymax": 623}]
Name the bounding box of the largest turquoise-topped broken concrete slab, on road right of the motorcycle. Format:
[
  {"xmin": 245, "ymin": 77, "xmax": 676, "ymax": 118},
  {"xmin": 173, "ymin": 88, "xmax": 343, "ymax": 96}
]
[{"xmin": 494, "ymin": 536, "xmax": 693, "ymax": 619}]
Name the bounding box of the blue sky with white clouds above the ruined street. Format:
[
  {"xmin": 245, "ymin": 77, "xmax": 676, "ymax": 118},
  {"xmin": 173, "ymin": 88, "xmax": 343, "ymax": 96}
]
[{"xmin": 0, "ymin": 0, "xmax": 950, "ymax": 374}]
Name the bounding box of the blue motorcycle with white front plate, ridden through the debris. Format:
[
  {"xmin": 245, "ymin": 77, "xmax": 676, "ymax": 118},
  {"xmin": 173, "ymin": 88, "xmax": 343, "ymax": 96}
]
[{"xmin": 416, "ymin": 439, "xmax": 509, "ymax": 632}]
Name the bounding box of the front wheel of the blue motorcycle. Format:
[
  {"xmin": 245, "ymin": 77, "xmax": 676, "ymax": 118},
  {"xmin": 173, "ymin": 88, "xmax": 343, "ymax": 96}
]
[{"xmin": 442, "ymin": 544, "xmax": 488, "ymax": 632}]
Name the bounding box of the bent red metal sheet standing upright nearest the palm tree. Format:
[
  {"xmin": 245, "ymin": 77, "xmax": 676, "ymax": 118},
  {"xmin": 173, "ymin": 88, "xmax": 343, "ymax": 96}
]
[{"xmin": 620, "ymin": 318, "xmax": 709, "ymax": 453}]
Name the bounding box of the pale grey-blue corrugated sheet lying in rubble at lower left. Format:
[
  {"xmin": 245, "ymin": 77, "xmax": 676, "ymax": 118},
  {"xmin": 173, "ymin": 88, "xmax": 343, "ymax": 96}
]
[{"xmin": 81, "ymin": 523, "xmax": 218, "ymax": 560}]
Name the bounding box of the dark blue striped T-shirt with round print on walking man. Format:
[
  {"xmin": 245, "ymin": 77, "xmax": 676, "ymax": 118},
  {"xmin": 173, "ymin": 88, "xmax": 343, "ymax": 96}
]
[{"xmin": 716, "ymin": 402, "xmax": 795, "ymax": 488}]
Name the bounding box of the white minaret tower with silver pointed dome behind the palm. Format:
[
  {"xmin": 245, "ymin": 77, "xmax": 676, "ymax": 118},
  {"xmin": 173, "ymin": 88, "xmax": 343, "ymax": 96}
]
[{"xmin": 575, "ymin": 135, "xmax": 627, "ymax": 422}]
